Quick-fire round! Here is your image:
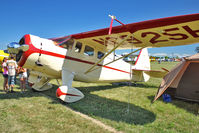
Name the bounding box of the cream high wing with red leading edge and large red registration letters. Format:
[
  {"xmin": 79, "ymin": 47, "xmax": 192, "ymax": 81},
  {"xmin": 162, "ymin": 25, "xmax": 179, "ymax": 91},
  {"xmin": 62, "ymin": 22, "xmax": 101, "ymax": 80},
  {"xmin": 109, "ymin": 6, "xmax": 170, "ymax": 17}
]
[{"xmin": 52, "ymin": 13, "xmax": 199, "ymax": 49}]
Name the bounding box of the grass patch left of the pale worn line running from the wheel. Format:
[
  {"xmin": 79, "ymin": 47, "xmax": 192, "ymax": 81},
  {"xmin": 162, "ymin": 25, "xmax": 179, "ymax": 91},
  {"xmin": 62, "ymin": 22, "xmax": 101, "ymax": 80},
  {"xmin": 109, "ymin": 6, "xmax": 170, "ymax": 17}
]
[{"xmin": 0, "ymin": 76, "xmax": 111, "ymax": 133}]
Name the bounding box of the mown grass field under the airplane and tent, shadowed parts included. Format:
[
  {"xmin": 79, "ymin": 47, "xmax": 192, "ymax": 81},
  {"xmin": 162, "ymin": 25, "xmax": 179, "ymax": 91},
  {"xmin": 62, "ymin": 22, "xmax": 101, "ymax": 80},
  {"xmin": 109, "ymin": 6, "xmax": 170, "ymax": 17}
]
[{"xmin": 0, "ymin": 62, "xmax": 199, "ymax": 133}]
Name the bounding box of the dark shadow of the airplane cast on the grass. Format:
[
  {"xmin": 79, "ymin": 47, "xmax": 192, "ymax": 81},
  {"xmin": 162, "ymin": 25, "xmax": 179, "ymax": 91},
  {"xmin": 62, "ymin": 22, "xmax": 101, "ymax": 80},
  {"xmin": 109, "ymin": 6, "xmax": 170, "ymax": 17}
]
[{"xmin": 46, "ymin": 85, "xmax": 156, "ymax": 125}]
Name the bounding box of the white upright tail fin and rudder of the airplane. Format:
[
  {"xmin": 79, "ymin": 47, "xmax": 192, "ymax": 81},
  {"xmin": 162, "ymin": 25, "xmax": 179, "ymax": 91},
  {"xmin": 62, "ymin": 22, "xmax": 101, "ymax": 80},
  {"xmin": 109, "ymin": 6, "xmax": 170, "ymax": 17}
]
[{"xmin": 132, "ymin": 48, "xmax": 151, "ymax": 82}]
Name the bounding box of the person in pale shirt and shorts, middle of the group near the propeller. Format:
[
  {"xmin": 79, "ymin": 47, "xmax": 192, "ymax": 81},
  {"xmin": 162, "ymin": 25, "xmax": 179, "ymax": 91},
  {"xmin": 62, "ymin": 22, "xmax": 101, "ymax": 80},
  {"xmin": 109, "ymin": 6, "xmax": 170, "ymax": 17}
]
[{"xmin": 7, "ymin": 56, "xmax": 17, "ymax": 92}]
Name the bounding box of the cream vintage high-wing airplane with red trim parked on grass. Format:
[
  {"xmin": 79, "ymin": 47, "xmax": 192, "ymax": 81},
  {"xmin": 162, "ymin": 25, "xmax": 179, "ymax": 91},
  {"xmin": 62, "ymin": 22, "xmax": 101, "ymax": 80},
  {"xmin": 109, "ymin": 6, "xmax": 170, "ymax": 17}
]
[{"xmin": 8, "ymin": 14, "xmax": 199, "ymax": 103}]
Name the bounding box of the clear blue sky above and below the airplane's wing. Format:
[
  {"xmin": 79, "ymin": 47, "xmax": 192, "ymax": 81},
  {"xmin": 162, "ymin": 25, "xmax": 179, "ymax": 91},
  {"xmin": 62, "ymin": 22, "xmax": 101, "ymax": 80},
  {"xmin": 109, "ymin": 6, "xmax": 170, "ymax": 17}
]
[{"xmin": 0, "ymin": 0, "xmax": 199, "ymax": 56}]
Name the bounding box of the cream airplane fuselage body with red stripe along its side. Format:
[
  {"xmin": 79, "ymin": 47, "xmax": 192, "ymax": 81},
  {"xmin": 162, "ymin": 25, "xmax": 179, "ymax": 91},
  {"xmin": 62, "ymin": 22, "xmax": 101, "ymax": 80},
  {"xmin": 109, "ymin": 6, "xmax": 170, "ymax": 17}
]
[{"xmin": 20, "ymin": 35, "xmax": 132, "ymax": 82}]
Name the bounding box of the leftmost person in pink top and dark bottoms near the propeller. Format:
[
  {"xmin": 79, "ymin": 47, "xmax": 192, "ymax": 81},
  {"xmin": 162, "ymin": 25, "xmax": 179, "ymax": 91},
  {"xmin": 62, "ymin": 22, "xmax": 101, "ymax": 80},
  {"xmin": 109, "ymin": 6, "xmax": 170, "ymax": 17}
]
[{"xmin": 2, "ymin": 57, "xmax": 8, "ymax": 93}]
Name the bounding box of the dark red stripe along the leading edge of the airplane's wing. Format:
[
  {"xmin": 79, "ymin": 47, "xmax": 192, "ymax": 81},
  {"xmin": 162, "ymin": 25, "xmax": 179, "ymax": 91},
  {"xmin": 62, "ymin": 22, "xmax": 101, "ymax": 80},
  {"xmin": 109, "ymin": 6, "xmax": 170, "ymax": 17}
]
[{"xmin": 52, "ymin": 13, "xmax": 199, "ymax": 41}]
